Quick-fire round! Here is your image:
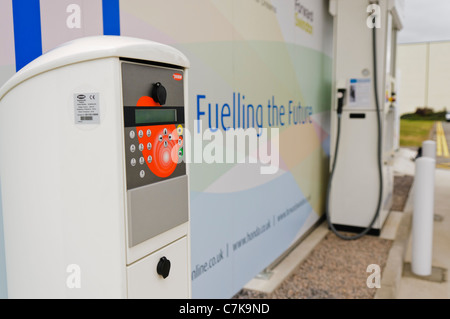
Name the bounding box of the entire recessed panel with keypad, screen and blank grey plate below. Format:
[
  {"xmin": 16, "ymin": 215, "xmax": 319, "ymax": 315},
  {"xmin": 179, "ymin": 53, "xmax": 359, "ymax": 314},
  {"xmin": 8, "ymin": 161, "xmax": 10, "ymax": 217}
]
[{"xmin": 121, "ymin": 59, "xmax": 188, "ymax": 247}]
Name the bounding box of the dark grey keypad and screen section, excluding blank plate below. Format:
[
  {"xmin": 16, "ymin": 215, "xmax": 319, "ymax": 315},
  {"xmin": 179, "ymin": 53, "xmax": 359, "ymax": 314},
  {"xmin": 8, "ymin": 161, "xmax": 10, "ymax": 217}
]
[{"xmin": 122, "ymin": 61, "xmax": 186, "ymax": 190}]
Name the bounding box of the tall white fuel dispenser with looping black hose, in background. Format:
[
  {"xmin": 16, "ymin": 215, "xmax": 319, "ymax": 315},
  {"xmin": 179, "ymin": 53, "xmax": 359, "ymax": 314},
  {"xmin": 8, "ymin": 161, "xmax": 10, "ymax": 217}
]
[{"xmin": 326, "ymin": 0, "xmax": 404, "ymax": 239}]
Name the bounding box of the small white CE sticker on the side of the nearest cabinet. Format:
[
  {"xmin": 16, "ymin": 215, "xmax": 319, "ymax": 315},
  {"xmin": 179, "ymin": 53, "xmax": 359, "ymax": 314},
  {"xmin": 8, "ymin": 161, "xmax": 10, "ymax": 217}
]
[{"xmin": 74, "ymin": 93, "xmax": 100, "ymax": 124}]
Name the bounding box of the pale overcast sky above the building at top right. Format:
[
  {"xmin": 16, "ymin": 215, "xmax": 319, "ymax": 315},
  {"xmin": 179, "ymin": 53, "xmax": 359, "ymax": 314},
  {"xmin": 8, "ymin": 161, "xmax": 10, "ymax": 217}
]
[{"xmin": 398, "ymin": 0, "xmax": 450, "ymax": 43}]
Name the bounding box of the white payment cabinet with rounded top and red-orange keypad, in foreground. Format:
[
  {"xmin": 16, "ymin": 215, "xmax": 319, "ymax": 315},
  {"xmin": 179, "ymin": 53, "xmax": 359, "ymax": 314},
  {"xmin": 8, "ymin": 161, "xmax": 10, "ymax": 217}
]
[{"xmin": 0, "ymin": 36, "xmax": 191, "ymax": 298}]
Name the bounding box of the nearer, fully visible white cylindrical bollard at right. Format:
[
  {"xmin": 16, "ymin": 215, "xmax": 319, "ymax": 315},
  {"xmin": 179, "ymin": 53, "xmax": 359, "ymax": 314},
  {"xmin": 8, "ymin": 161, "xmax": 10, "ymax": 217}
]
[{"xmin": 411, "ymin": 157, "xmax": 436, "ymax": 276}]
